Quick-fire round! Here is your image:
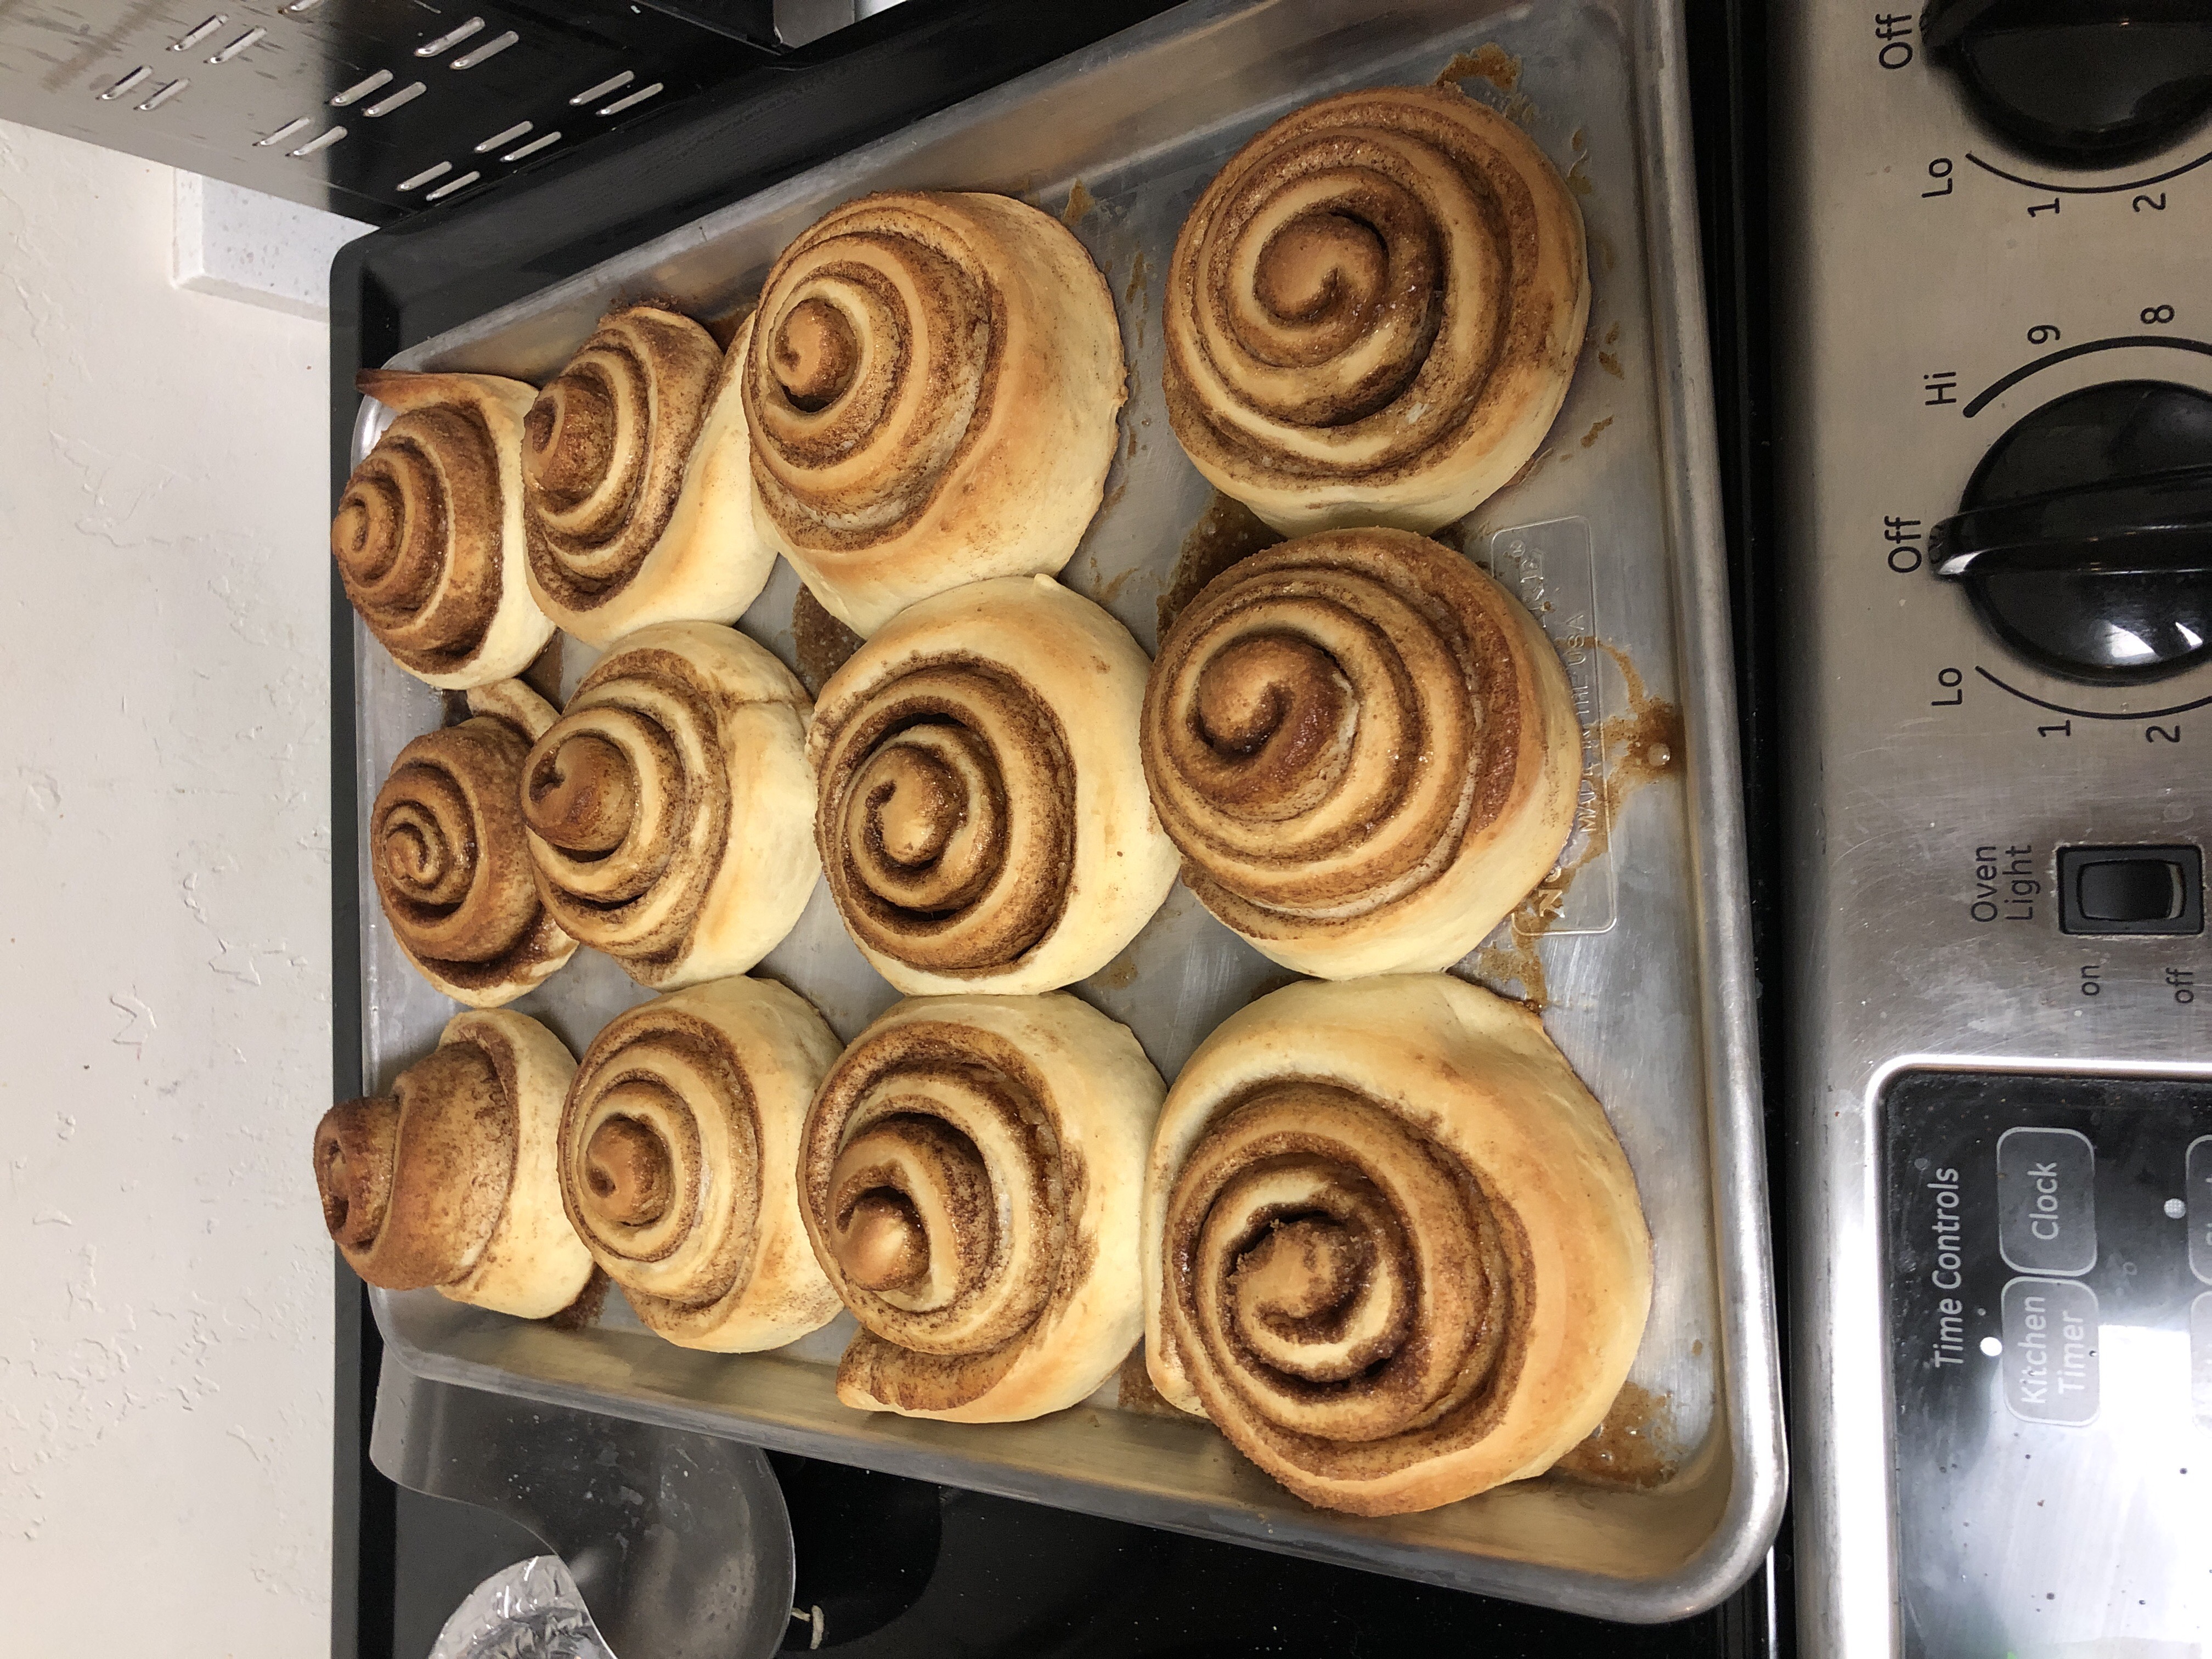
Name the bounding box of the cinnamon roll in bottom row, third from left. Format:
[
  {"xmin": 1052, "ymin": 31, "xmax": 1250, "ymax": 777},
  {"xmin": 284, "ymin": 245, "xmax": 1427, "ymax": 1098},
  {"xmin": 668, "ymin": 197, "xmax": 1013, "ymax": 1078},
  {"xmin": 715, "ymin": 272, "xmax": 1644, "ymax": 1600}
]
[{"xmin": 799, "ymin": 995, "xmax": 1161, "ymax": 1423}]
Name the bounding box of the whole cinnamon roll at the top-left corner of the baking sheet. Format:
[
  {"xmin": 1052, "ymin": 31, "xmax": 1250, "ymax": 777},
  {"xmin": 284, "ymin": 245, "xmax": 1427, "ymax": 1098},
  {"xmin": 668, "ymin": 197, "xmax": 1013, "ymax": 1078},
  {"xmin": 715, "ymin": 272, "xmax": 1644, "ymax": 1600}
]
[{"xmin": 330, "ymin": 369, "xmax": 553, "ymax": 690}]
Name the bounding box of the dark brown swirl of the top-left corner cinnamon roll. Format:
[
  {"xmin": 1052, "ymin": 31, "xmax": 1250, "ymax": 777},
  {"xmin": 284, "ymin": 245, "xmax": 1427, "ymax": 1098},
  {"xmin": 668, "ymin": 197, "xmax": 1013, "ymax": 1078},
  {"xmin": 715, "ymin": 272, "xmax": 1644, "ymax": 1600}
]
[{"xmin": 330, "ymin": 407, "xmax": 506, "ymax": 675}]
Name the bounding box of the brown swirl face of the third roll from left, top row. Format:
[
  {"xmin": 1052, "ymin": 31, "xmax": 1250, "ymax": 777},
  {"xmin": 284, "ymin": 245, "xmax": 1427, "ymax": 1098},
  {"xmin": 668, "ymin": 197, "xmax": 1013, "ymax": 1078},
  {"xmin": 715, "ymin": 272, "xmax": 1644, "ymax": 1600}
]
[{"xmin": 743, "ymin": 195, "xmax": 1005, "ymax": 551}]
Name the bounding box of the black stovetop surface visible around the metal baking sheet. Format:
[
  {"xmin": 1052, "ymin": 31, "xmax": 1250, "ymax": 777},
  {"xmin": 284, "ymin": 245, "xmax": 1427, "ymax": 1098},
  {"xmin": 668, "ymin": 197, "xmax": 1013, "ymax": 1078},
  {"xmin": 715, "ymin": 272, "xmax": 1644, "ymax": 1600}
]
[{"xmin": 330, "ymin": 0, "xmax": 1790, "ymax": 1659}]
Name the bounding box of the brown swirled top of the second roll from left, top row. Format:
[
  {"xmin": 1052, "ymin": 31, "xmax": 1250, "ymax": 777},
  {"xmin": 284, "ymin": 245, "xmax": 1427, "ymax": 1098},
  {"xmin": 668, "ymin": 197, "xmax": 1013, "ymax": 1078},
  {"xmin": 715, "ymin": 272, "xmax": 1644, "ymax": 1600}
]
[{"xmin": 522, "ymin": 305, "xmax": 721, "ymax": 611}]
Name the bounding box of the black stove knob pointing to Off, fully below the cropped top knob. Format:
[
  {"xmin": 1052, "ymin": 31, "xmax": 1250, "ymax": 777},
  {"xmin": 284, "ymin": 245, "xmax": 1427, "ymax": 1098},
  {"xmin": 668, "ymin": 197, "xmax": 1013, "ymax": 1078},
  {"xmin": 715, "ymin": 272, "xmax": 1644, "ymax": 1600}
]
[{"xmin": 1929, "ymin": 381, "xmax": 2212, "ymax": 686}]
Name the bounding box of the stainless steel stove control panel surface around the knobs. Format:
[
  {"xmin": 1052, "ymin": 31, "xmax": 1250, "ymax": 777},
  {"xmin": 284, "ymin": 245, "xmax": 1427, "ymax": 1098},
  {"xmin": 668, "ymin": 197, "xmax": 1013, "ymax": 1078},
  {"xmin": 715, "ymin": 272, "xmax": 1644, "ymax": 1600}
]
[{"xmin": 1772, "ymin": 0, "xmax": 2212, "ymax": 1657}]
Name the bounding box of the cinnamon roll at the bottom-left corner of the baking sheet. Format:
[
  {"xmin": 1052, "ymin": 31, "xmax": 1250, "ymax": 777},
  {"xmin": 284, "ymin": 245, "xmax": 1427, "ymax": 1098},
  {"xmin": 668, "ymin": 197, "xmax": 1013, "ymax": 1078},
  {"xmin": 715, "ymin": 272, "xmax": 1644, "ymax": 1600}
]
[{"xmin": 314, "ymin": 1009, "xmax": 591, "ymax": 1318}]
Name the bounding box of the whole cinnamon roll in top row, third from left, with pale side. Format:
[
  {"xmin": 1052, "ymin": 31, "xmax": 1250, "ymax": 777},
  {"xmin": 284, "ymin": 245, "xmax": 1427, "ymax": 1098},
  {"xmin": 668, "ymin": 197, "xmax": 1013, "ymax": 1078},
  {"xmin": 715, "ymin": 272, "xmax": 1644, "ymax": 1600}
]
[{"xmin": 743, "ymin": 193, "xmax": 1126, "ymax": 635}]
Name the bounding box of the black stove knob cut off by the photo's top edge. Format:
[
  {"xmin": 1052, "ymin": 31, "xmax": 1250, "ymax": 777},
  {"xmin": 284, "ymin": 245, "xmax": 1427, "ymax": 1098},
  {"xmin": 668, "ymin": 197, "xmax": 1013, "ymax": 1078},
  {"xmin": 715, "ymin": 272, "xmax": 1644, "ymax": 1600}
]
[{"xmin": 1920, "ymin": 0, "xmax": 2212, "ymax": 166}]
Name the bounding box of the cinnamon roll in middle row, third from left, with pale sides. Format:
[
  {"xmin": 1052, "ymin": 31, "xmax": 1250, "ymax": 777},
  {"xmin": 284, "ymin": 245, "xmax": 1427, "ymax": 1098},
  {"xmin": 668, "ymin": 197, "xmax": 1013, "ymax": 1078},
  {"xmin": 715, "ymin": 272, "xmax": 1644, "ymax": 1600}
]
[{"xmin": 808, "ymin": 575, "xmax": 1175, "ymax": 995}]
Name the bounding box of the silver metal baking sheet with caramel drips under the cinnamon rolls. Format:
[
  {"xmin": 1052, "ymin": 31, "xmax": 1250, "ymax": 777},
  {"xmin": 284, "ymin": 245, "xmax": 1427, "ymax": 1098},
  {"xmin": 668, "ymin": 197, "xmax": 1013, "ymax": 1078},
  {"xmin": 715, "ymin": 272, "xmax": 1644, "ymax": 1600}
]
[{"xmin": 354, "ymin": 0, "xmax": 1785, "ymax": 1621}]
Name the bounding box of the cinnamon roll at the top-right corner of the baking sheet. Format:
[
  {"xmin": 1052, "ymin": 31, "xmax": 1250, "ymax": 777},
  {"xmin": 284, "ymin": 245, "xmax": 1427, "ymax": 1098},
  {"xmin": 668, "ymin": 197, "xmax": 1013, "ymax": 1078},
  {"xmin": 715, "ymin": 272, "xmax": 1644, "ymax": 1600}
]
[{"xmin": 1166, "ymin": 86, "xmax": 1590, "ymax": 535}]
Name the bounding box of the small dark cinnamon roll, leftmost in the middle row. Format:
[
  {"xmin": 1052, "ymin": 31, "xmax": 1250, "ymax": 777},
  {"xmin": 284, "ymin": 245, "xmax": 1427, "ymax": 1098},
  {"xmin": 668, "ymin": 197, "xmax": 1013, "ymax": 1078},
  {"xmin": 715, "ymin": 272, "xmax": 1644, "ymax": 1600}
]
[{"xmin": 369, "ymin": 679, "xmax": 575, "ymax": 1009}]
